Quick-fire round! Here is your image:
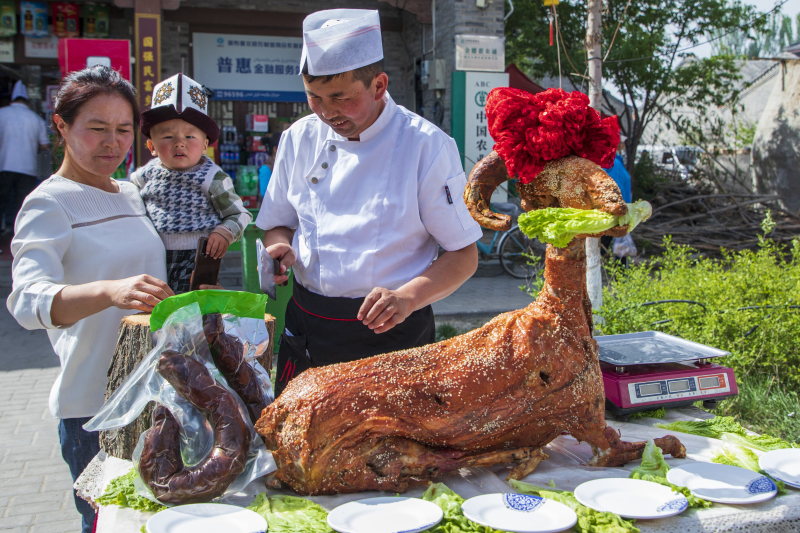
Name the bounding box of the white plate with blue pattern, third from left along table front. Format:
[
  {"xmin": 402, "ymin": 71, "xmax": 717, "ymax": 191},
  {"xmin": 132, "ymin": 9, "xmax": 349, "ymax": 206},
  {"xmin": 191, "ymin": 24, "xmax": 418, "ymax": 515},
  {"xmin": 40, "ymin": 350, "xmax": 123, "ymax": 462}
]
[{"xmin": 461, "ymin": 493, "xmax": 578, "ymax": 533}]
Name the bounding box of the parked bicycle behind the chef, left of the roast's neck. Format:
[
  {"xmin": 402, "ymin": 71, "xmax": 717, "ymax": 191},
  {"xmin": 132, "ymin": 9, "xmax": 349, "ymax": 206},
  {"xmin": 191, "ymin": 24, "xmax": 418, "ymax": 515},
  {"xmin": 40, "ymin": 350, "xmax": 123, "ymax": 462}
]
[{"xmin": 476, "ymin": 203, "xmax": 547, "ymax": 280}]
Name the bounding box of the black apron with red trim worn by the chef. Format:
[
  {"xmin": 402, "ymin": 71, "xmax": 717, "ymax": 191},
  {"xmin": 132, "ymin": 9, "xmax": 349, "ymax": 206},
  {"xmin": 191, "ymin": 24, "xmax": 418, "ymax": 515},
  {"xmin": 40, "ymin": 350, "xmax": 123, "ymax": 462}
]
[{"xmin": 275, "ymin": 279, "xmax": 436, "ymax": 397}]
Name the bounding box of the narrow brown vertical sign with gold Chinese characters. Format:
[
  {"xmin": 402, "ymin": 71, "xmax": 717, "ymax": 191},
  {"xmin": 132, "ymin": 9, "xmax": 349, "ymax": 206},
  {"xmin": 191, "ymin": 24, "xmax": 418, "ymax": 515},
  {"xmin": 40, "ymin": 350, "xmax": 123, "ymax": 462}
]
[{"xmin": 135, "ymin": 13, "xmax": 161, "ymax": 165}]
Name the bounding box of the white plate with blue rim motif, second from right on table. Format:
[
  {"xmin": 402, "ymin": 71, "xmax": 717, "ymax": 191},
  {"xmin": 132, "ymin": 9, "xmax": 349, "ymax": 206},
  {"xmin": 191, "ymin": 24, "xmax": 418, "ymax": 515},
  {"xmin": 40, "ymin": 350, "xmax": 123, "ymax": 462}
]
[{"xmin": 667, "ymin": 463, "xmax": 778, "ymax": 504}]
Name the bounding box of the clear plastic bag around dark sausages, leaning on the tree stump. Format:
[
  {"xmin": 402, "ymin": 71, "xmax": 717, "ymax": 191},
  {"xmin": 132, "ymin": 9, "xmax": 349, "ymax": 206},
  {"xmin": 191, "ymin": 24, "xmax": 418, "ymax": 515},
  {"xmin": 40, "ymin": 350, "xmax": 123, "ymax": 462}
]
[{"xmin": 84, "ymin": 300, "xmax": 276, "ymax": 504}]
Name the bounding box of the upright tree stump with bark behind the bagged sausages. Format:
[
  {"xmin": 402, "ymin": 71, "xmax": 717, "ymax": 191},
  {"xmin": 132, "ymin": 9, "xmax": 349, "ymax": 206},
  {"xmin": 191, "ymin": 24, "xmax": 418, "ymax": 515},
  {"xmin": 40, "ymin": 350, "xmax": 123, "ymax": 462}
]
[{"xmin": 100, "ymin": 313, "xmax": 275, "ymax": 460}]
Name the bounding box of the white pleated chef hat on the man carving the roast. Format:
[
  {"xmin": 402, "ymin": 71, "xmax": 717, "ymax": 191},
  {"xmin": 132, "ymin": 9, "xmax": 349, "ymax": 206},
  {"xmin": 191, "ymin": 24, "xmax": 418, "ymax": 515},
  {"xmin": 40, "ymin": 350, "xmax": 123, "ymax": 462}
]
[{"xmin": 300, "ymin": 9, "xmax": 383, "ymax": 76}]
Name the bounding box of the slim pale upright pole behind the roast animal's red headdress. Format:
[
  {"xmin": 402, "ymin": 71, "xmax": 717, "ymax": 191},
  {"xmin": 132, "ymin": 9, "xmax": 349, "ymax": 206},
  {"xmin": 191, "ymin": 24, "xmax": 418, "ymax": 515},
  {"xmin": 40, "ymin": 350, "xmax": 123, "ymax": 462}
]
[{"xmin": 585, "ymin": 0, "xmax": 603, "ymax": 318}]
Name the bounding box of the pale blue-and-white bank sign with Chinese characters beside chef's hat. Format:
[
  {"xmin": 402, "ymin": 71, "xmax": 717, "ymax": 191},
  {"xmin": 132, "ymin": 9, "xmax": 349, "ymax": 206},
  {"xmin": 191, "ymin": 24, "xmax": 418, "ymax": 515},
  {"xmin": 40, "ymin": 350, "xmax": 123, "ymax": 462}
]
[{"xmin": 192, "ymin": 33, "xmax": 306, "ymax": 102}]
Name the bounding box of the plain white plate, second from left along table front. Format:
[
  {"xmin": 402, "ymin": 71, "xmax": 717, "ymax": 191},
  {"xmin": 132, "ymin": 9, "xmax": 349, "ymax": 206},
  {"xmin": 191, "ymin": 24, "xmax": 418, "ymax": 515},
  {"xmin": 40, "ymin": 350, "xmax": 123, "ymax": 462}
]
[{"xmin": 328, "ymin": 497, "xmax": 443, "ymax": 533}]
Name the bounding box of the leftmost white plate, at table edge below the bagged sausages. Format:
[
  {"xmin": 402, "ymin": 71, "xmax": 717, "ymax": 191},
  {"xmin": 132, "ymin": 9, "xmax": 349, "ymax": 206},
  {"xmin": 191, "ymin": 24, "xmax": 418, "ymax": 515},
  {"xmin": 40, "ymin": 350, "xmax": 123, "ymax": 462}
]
[{"xmin": 146, "ymin": 503, "xmax": 267, "ymax": 533}]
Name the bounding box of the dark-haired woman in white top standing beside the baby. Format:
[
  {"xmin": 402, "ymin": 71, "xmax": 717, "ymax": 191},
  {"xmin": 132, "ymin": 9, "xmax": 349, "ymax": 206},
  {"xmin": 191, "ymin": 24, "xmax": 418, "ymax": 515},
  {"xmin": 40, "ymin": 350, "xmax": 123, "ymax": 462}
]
[{"xmin": 7, "ymin": 67, "xmax": 173, "ymax": 533}]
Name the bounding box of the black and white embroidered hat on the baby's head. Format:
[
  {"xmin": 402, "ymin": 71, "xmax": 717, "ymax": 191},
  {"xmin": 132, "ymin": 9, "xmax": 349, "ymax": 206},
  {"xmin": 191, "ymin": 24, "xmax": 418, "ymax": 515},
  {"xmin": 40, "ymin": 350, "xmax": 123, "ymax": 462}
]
[{"xmin": 142, "ymin": 74, "xmax": 219, "ymax": 143}]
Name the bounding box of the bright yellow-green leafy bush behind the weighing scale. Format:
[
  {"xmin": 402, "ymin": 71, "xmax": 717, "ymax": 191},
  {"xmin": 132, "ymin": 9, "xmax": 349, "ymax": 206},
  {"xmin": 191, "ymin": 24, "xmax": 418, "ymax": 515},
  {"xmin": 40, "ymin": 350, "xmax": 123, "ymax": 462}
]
[{"xmin": 597, "ymin": 235, "xmax": 800, "ymax": 391}]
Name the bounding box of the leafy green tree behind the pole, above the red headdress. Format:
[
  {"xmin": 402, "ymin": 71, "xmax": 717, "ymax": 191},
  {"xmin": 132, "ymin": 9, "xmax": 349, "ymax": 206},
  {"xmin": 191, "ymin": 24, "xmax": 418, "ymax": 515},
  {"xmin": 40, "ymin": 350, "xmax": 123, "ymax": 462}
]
[{"xmin": 506, "ymin": 0, "xmax": 763, "ymax": 183}]
